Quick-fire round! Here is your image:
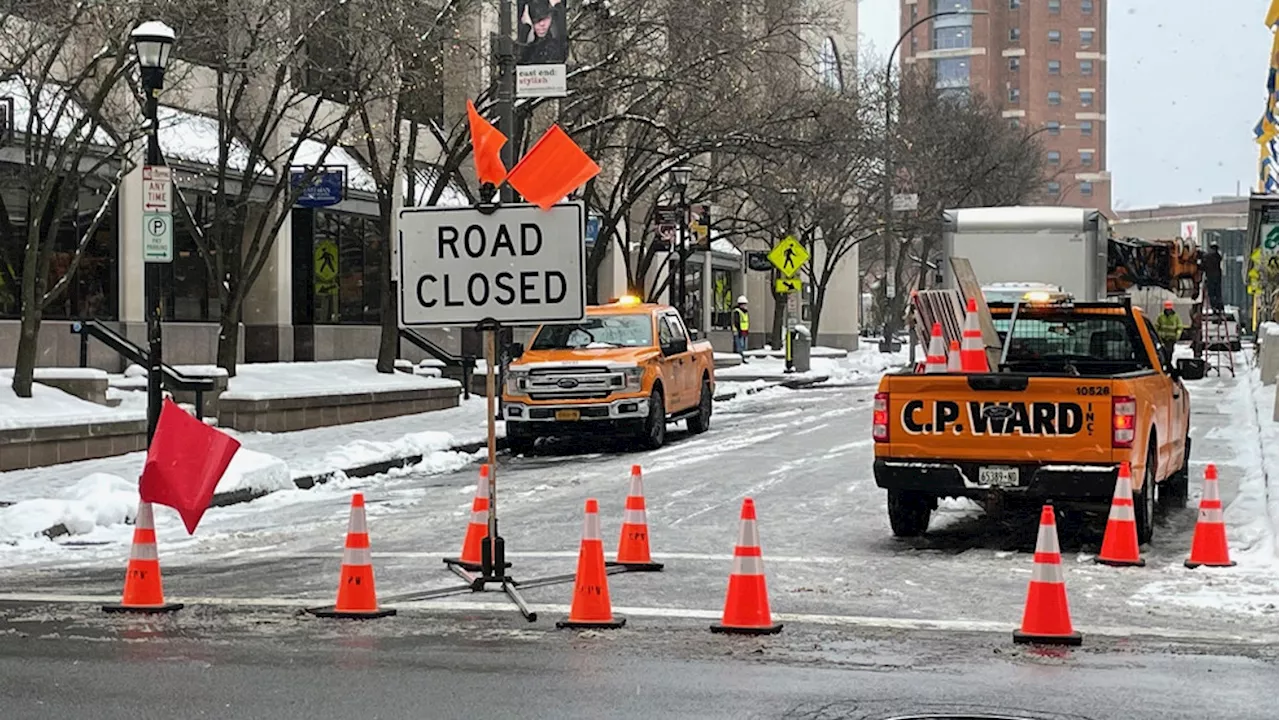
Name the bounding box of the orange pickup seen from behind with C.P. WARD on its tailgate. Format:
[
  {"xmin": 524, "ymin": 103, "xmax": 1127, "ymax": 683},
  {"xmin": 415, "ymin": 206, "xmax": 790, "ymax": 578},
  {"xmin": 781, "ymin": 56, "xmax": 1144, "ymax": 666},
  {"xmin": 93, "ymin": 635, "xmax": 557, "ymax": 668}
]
[{"xmin": 872, "ymin": 295, "xmax": 1190, "ymax": 542}]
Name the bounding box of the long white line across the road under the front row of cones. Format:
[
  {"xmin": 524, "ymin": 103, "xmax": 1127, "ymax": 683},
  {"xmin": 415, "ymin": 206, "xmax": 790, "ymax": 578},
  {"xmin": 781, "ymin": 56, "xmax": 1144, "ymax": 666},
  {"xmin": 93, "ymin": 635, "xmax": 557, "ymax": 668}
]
[{"xmin": 0, "ymin": 593, "xmax": 1277, "ymax": 646}]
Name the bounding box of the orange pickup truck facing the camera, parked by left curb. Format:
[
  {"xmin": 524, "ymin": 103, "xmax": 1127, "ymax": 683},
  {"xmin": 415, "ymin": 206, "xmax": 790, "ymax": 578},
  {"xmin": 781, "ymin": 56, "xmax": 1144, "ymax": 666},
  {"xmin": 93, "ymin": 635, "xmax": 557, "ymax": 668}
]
[{"xmin": 502, "ymin": 297, "xmax": 716, "ymax": 455}]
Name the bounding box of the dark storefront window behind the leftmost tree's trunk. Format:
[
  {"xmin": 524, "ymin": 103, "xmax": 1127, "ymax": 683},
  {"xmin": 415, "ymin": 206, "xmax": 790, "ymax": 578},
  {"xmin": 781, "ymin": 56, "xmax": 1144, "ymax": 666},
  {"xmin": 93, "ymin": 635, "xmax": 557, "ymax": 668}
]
[{"xmin": 0, "ymin": 175, "xmax": 119, "ymax": 317}]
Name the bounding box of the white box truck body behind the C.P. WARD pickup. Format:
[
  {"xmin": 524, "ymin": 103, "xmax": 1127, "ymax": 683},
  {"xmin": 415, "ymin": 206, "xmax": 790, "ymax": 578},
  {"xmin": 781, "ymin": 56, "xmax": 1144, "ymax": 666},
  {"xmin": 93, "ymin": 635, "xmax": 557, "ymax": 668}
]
[{"xmin": 942, "ymin": 206, "xmax": 1111, "ymax": 302}]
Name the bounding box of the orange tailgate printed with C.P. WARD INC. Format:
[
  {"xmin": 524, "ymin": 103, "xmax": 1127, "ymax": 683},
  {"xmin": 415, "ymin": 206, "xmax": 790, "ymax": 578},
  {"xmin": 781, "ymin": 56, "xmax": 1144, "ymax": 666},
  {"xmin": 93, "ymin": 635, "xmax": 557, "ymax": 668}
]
[{"xmin": 877, "ymin": 374, "xmax": 1114, "ymax": 464}]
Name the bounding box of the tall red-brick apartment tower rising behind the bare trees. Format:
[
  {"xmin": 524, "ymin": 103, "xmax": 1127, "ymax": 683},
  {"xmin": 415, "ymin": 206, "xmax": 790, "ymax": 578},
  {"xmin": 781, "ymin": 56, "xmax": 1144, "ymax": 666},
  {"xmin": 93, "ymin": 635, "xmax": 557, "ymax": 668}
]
[{"xmin": 900, "ymin": 0, "xmax": 1111, "ymax": 213}]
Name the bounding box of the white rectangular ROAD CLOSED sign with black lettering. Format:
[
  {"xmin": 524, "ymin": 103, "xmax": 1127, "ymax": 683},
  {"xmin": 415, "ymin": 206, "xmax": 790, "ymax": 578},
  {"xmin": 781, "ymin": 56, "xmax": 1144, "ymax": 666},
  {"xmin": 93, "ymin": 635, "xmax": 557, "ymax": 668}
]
[{"xmin": 399, "ymin": 202, "xmax": 586, "ymax": 327}]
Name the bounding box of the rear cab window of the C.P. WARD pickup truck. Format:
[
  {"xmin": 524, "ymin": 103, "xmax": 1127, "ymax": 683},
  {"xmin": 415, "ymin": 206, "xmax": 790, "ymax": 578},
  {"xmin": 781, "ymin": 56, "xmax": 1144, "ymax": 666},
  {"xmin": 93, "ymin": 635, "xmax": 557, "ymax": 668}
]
[{"xmin": 995, "ymin": 313, "xmax": 1151, "ymax": 375}]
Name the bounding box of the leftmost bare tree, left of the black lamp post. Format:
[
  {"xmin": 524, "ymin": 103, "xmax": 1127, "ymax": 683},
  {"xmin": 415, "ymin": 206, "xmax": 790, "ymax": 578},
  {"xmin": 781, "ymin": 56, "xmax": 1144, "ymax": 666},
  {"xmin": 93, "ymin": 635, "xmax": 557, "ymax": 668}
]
[{"xmin": 0, "ymin": 3, "xmax": 141, "ymax": 397}]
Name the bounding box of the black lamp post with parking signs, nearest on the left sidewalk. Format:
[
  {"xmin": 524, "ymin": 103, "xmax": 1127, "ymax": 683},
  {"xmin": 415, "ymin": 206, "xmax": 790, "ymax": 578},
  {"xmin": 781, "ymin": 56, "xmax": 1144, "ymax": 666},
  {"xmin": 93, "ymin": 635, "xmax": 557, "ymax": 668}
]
[{"xmin": 132, "ymin": 20, "xmax": 174, "ymax": 445}]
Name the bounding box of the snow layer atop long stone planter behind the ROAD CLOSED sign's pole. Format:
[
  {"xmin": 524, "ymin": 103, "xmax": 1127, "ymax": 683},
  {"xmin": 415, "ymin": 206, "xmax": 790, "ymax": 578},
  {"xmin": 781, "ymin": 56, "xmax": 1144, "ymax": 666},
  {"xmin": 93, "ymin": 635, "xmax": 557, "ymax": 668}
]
[{"xmin": 223, "ymin": 360, "xmax": 461, "ymax": 400}]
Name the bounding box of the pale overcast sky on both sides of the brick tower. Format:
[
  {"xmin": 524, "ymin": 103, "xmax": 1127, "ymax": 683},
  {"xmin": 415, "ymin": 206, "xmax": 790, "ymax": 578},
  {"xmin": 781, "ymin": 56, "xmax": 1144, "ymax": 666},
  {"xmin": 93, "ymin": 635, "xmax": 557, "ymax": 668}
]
[{"xmin": 859, "ymin": 0, "xmax": 1271, "ymax": 210}]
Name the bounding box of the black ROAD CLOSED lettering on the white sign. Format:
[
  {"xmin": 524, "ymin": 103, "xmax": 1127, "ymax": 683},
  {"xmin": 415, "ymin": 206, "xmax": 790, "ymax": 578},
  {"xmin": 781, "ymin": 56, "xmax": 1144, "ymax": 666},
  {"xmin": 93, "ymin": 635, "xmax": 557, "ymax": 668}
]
[{"xmin": 415, "ymin": 223, "xmax": 568, "ymax": 309}]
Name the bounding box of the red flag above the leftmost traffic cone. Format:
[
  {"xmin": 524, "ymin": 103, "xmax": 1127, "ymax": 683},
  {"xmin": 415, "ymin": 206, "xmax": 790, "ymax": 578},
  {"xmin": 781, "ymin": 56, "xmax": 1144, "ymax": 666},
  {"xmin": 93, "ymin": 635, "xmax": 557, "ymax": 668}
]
[{"xmin": 138, "ymin": 398, "xmax": 239, "ymax": 534}]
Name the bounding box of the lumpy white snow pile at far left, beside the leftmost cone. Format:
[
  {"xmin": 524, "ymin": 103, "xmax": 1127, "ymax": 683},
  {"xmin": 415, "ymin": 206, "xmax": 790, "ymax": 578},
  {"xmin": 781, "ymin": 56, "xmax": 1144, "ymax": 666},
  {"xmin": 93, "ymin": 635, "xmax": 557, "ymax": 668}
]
[{"xmin": 0, "ymin": 473, "xmax": 138, "ymax": 543}]
